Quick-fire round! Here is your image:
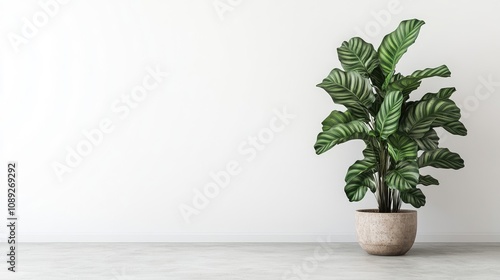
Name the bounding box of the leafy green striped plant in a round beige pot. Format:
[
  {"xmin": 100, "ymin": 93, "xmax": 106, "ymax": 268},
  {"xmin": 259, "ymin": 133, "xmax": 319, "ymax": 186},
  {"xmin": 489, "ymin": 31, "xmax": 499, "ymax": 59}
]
[{"xmin": 314, "ymin": 19, "xmax": 467, "ymax": 255}]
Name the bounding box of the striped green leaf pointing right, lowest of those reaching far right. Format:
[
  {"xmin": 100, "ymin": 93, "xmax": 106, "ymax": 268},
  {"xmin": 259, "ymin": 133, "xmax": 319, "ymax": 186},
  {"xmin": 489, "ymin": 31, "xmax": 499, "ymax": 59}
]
[{"xmin": 418, "ymin": 148, "xmax": 464, "ymax": 169}]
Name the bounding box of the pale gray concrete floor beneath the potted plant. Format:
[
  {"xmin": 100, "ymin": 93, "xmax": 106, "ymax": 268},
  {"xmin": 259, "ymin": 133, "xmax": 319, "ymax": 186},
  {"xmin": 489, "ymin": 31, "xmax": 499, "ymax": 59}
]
[{"xmin": 0, "ymin": 243, "xmax": 500, "ymax": 280}]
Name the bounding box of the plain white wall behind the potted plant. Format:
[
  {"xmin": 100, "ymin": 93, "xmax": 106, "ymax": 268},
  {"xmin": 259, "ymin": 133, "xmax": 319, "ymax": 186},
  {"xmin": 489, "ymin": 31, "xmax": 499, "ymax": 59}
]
[{"xmin": 0, "ymin": 0, "xmax": 500, "ymax": 241}]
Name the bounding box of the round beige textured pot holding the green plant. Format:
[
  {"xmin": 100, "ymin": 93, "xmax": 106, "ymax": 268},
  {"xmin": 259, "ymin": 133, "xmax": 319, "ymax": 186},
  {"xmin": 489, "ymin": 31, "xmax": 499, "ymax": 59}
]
[{"xmin": 356, "ymin": 209, "xmax": 417, "ymax": 256}]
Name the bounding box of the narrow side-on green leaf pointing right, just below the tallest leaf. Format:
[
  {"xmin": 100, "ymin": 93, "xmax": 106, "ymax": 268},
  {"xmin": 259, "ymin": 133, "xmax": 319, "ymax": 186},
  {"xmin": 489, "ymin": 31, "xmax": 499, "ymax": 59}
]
[{"xmin": 388, "ymin": 65, "xmax": 451, "ymax": 92}]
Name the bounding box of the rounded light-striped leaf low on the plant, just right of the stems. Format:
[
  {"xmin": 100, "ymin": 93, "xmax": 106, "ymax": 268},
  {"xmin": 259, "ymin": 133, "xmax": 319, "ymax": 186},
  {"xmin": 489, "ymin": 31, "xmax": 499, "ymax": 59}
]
[{"xmin": 385, "ymin": 161, "xmax": 419, "ymax": 191}]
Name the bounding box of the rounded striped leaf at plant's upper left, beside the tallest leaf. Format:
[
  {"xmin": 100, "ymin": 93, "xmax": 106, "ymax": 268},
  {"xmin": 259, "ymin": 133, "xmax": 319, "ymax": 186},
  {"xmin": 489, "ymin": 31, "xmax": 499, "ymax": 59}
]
[{"xmin": 337, "ymin": 37, "xmax": 378, "ymax": 78}]
